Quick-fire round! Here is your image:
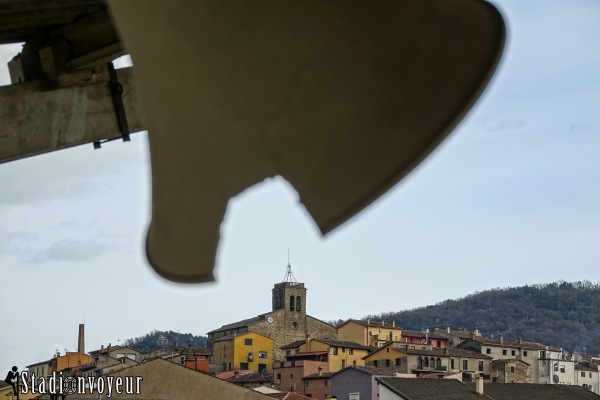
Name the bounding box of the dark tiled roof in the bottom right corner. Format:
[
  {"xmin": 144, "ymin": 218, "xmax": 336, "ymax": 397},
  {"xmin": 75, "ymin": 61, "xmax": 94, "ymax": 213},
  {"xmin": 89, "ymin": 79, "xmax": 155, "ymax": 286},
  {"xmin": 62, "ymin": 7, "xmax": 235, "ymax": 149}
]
[{"xmin": 471, "ymin": 383, "xmax": 598, "ymax": 400}]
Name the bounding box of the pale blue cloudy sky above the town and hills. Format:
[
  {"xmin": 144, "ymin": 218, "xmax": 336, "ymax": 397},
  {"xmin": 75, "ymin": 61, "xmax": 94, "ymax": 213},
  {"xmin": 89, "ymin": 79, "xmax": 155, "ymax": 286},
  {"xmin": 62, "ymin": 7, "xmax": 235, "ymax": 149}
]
[{"xmin": 0, "ymin": 0, "xmax": 600, "ymax": 371}]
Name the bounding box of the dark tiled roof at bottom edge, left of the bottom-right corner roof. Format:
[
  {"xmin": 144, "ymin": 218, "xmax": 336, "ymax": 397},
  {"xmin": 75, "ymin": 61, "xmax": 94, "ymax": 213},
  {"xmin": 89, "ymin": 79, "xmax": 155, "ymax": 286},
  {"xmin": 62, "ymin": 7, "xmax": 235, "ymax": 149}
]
[{"xmin": 376, "ymin": 377, "xmax": 490, "ymax": 400}]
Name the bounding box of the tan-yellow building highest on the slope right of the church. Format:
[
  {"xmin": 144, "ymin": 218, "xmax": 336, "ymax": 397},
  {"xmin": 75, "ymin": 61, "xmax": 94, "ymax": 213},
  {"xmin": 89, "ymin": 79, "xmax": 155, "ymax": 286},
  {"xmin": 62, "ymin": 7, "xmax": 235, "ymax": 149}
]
[{"xmin": 338, "ymin": 319, "xmax": 402, "ymax": 347}]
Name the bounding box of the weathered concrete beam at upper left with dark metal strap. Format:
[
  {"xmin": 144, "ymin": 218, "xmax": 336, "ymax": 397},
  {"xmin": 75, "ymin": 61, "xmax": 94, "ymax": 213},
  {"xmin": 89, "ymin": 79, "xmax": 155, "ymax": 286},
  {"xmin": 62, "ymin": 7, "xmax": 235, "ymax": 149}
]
[{"xmin": 0, "ymin": 68, "xmax": 146, "ymax": 163}]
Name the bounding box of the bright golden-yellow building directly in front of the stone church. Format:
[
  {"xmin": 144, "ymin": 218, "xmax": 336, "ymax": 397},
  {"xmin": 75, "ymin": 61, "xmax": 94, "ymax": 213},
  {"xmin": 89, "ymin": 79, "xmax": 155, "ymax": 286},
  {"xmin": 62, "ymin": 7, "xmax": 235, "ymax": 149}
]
[{"xmin": 213, "ymin": 332, "xmax": 273, "ymax": 372}]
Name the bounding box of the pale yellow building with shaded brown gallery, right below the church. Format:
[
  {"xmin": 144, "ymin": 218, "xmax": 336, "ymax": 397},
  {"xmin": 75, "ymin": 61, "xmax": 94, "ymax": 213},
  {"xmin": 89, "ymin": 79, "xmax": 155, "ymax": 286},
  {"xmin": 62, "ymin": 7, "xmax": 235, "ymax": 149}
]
[{"xmin": 283, "ymin": 337, "xmax": 374, "ymax": 372}]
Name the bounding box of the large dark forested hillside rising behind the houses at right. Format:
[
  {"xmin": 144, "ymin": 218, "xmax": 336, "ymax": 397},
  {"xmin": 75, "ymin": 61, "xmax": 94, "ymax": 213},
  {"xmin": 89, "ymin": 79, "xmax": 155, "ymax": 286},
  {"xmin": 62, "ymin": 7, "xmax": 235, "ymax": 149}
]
[{"xmin": 365, "ymin": 281, "xmax": 600, "ymax": 355}]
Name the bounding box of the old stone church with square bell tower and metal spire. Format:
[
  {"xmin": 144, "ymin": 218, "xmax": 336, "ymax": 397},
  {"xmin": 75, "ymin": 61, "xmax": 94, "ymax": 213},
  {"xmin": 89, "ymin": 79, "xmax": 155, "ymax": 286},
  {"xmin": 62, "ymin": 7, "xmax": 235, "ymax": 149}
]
[{"xmin": 208, "ymin": 264, "xmax": 337, "ymax": 370}]
